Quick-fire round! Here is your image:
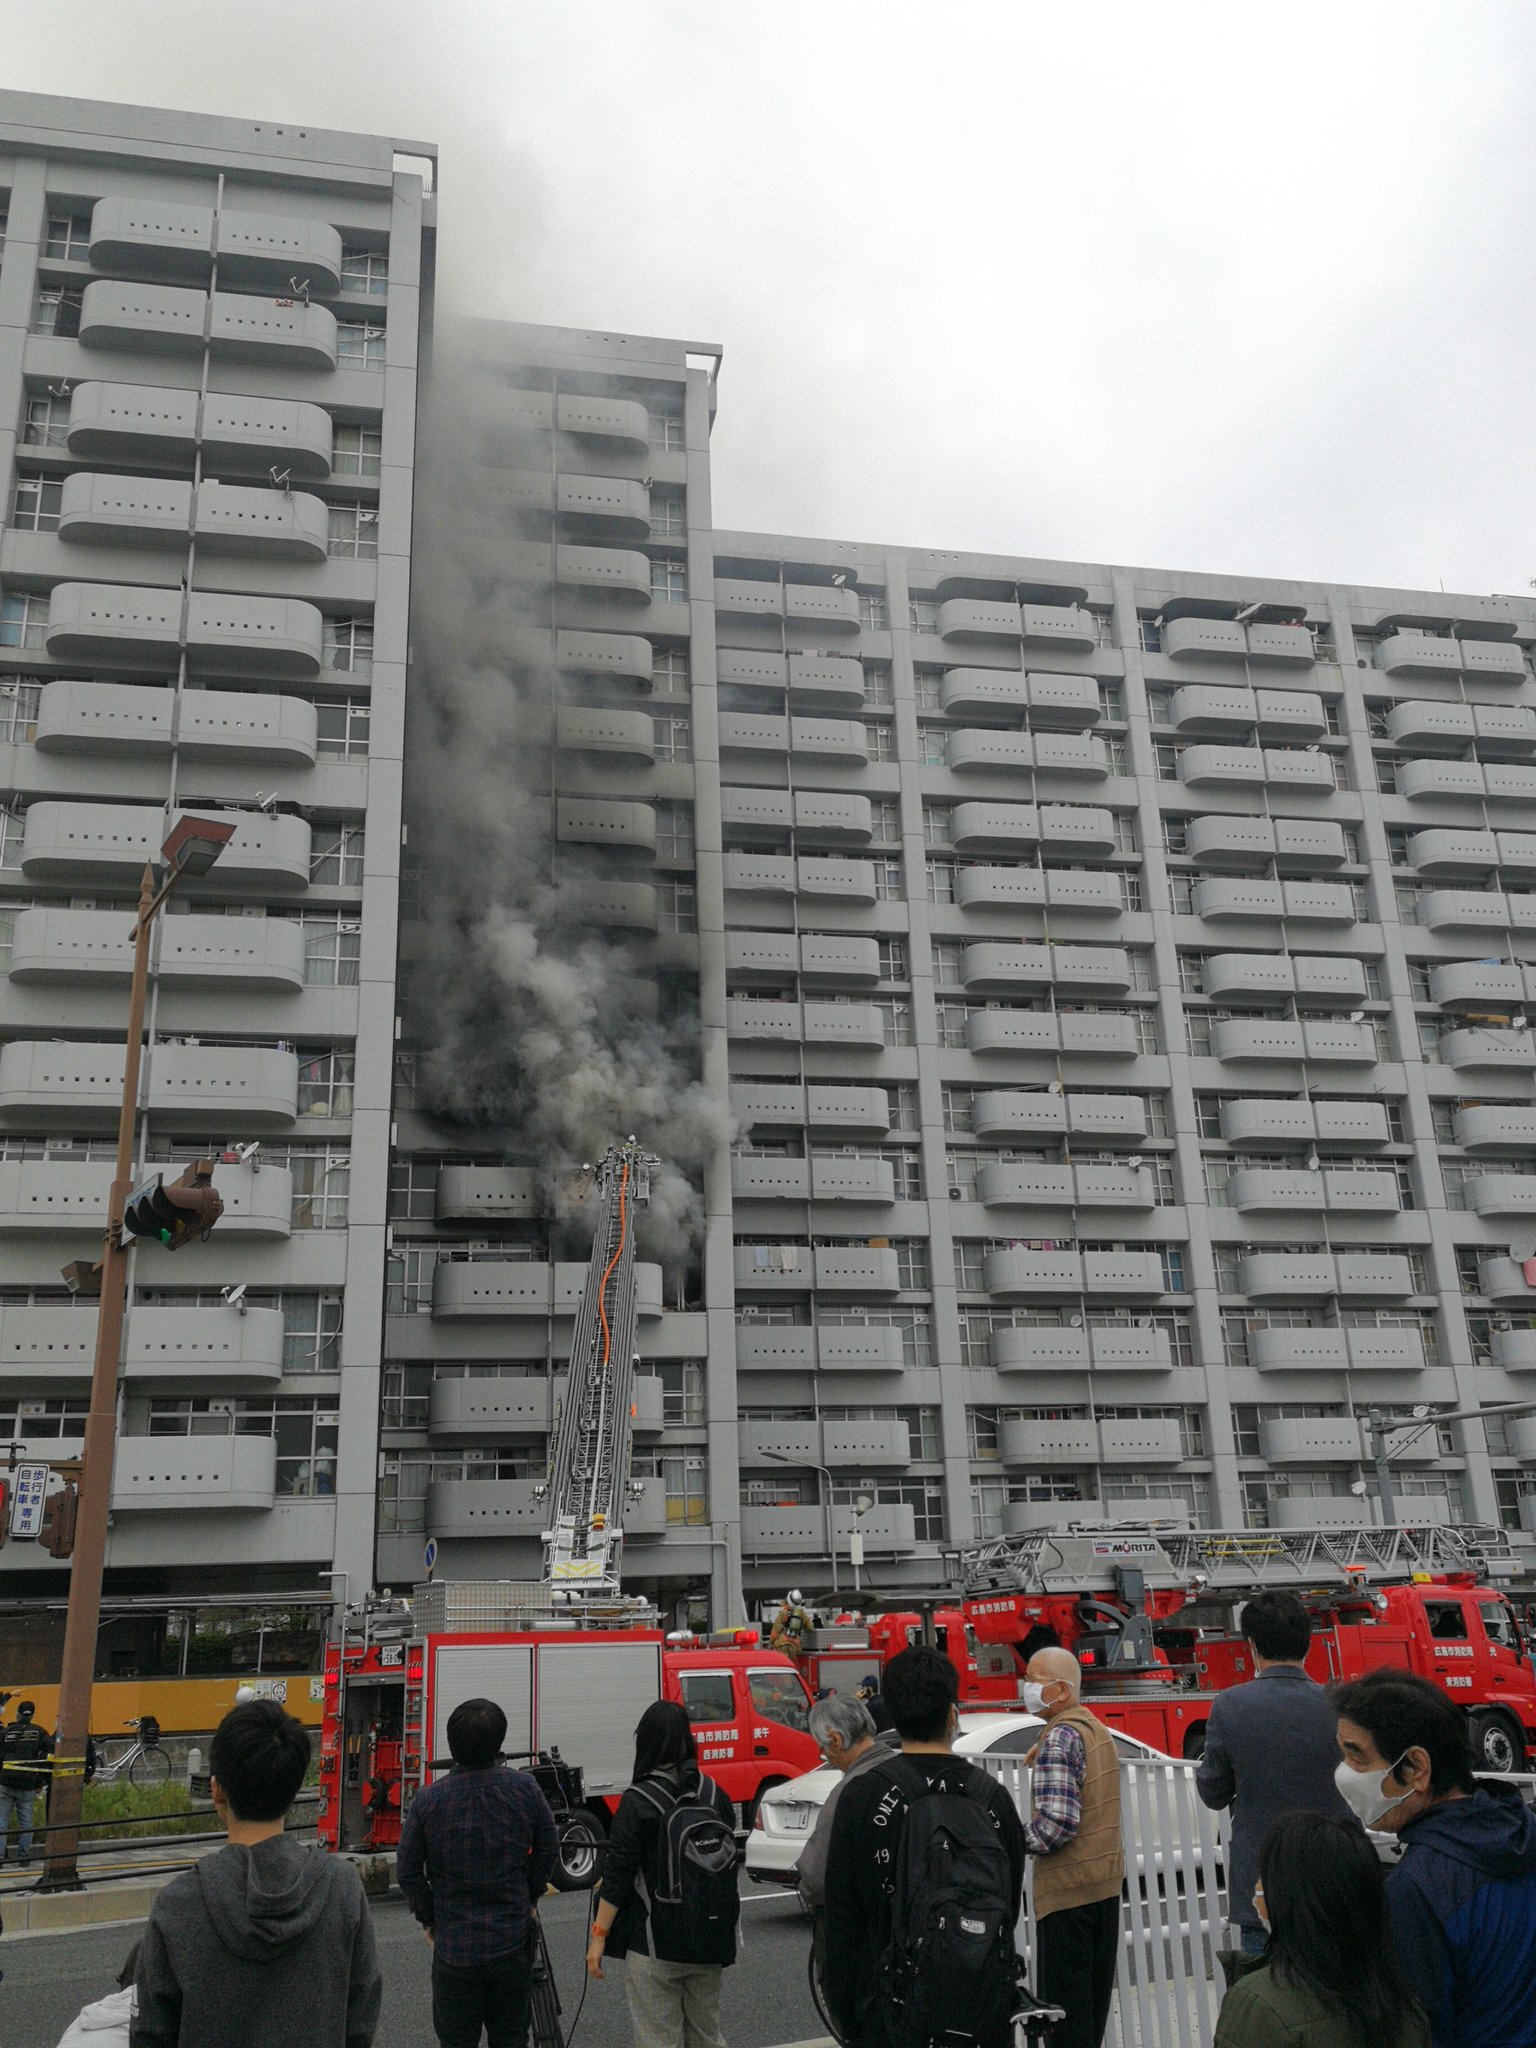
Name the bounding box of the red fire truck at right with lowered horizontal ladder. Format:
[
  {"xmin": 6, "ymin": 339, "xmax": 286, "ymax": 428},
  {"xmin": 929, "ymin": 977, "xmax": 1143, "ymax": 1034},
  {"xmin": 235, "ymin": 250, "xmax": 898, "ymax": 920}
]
[{"xmin": 803, "ymin": 1528, "xmax": 1536, "ymax": 1772}]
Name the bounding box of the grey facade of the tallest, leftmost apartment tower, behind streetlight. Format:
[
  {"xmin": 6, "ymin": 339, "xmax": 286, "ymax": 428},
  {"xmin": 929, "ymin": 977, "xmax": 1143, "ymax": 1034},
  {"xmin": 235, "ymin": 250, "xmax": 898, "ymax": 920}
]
[{"xmin": 0, "ymin": 94, "xmax": 432, "ymax": 1595}]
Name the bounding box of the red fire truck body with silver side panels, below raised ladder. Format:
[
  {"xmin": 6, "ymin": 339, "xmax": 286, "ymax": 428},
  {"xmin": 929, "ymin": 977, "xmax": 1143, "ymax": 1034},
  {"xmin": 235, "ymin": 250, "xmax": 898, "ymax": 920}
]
[{"xmin": 317, "ymin": 1581, "xmax": 819, "ymax": 1874}]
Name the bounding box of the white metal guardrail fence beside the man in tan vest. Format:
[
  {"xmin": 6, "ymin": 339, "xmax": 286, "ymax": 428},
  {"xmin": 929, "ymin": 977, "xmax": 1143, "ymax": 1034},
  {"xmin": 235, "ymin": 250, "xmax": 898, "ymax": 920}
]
[{"xmin": 973, "ymin": 1757, "xmax": 1536, "ymax": 2048}]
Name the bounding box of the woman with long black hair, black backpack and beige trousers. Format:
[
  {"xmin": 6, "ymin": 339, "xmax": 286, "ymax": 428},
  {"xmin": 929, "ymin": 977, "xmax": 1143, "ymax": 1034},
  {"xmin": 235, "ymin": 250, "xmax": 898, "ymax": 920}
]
[{"xmin": 586, "ymin": 1700, "xmax": 739, "ymax": 2048}]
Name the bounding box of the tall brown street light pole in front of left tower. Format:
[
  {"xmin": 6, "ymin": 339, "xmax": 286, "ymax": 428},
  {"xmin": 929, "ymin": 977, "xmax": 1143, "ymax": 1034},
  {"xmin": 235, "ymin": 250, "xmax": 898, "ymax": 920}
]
[{"xmin": 39, "ymin": 819, "xmax": 233, "ymax": 1892}]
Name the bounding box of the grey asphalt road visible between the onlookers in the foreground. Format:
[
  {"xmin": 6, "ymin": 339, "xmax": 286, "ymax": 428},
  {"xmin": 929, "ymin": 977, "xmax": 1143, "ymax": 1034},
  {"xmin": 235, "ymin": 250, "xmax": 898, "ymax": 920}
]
[{"xmin": 0, "ymin": 1878, "xmax": 825, "ymax": 2048}]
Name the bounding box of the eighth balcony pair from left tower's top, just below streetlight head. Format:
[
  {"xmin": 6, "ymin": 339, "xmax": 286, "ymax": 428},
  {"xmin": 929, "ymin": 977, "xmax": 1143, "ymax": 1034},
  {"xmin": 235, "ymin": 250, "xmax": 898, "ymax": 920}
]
[{"xmin": 10, "ymin": 905, "xmax": 305, "ymax": 995}]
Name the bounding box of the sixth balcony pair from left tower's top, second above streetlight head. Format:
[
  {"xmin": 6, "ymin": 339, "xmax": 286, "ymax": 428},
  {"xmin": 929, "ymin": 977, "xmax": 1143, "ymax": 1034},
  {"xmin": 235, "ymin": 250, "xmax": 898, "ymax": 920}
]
[{"xmin": 37, "ymin": 682, "xmax": 319, "ymax": 768}]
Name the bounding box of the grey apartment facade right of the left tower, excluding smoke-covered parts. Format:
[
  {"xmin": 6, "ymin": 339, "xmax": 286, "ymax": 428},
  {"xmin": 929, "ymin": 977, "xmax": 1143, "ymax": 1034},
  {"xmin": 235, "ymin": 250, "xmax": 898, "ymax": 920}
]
[{"xmin": 381, "ymin": 328, "xmax": 1536, "ymax": 1618}]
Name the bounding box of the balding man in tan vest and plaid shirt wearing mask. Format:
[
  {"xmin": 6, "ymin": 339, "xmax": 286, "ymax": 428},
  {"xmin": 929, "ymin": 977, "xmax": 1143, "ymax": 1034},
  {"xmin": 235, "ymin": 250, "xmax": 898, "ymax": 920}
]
[{"xmin": 1024, "ymin": 1649, "xmax": 1124, "ymax": 2048}]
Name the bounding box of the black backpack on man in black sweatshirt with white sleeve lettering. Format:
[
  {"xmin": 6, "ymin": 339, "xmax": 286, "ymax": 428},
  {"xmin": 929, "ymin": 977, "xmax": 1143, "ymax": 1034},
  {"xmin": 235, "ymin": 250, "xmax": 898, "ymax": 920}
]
[{"xmin": 877, "ymin": 1757, "xmax": 1020, "ymax": 2048}]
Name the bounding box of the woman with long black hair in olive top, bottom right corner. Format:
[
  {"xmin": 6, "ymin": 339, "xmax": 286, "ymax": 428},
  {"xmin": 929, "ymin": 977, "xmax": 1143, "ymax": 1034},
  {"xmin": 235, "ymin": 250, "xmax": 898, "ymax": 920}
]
[{"xmin": 1217, "ymin": 1812, "xmax": 1430, "ymax": 2048}]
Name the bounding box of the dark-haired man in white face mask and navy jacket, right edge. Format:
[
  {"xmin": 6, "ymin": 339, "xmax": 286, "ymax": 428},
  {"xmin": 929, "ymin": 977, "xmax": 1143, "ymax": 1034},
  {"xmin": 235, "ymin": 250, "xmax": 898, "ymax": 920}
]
[{"xmin": 1333, "ymin": 1671, "xmax": 1536, "ymax": 2048}]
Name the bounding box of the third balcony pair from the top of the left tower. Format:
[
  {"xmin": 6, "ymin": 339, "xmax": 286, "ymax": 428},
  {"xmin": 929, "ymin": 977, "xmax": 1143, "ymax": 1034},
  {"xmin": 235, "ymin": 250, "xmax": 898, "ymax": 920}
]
[{"xmin": 66, "ymin": 381, "xmax": 335, "ymax": 475}]
